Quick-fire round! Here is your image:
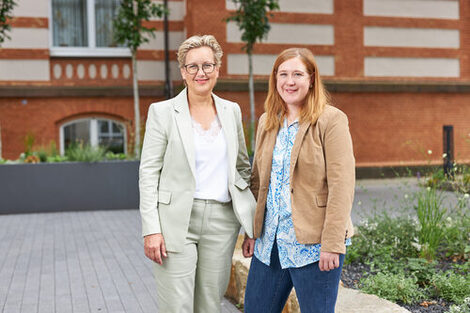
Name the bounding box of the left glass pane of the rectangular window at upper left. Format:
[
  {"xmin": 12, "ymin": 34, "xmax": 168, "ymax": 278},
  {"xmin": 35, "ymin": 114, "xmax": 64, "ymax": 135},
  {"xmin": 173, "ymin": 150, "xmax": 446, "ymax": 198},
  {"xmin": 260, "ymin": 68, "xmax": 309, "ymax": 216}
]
[{"xmin": 52, "ymin": 0, "xmax": 88, "ymax": 47}]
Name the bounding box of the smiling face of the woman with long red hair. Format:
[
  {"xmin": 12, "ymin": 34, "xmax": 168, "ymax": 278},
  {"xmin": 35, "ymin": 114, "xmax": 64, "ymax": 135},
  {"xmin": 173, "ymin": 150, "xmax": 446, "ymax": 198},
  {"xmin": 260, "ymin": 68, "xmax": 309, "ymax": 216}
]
[{"xmin": 276, "ymin": 57, "xmax": 311, "ymax": 106}]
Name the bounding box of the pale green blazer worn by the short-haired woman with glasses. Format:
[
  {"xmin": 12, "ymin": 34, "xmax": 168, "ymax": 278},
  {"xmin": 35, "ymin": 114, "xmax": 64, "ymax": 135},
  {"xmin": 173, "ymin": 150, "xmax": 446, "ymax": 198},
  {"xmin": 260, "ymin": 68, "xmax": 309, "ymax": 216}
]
[{"xmin": 139, "ymin": 89, "xmax": 256, "ymax": 252}]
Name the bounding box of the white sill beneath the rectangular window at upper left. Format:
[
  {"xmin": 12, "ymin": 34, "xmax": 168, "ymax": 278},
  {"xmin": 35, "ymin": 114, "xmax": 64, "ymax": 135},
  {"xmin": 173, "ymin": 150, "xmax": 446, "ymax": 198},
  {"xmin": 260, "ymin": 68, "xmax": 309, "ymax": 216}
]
[{"xmin": 50, "ymin": 47, "xmax": 132, "ymax": 58}]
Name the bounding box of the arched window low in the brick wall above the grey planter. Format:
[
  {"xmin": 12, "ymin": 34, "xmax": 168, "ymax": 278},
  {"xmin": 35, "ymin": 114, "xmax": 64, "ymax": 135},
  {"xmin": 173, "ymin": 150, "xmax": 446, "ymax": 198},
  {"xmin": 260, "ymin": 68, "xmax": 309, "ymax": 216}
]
[{"xmin": 60, "ymin": 118, "xmax": 127, "ymax": 155}]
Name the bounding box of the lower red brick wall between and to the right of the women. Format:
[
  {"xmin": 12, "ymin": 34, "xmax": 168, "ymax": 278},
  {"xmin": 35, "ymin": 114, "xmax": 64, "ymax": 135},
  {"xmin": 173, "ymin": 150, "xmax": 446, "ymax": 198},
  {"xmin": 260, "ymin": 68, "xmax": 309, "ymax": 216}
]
[{"xmin": 218, "ymin": 92, "xmax": 470, "ymax": 166}]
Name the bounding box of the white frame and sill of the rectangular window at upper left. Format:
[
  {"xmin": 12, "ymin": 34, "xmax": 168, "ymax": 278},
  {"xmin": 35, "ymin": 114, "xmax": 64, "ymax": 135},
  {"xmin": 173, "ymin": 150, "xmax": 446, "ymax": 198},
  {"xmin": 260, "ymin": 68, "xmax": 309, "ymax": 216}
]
[{"xmin": 49, "ymin": 0, "xmax": 132, "ymax": 57}]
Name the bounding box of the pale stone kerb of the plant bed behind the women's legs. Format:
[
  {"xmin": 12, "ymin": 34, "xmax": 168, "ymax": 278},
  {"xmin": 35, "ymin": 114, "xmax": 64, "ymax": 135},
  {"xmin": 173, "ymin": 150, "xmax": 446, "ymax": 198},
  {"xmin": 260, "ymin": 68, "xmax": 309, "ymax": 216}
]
[{"xmin": 225, "ymin": 235, "xmax": 410, "ymax": 313}]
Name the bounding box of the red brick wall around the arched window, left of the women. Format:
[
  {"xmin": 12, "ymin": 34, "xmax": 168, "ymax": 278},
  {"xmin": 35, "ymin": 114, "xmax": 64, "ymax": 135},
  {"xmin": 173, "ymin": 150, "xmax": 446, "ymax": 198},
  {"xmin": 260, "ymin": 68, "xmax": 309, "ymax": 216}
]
[{"xmin": 0, "ymin": 97, "xmax": 163, "ymax": 159}]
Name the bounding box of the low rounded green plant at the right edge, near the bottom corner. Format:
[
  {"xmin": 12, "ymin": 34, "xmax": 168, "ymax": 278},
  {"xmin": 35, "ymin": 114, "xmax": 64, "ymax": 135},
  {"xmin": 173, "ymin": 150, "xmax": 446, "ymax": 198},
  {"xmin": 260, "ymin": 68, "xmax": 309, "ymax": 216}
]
[{"xmin": 432, "ymin": 271, "xmax": 470, "ymax": 304}]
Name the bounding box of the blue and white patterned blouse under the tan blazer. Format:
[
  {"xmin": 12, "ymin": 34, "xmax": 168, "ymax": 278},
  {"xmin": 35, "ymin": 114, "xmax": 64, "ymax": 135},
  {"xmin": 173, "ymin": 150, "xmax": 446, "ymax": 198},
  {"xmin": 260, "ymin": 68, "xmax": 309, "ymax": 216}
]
[{"xmin": 255, "ymin": 119, "xmax": 351, "ymax": 268}]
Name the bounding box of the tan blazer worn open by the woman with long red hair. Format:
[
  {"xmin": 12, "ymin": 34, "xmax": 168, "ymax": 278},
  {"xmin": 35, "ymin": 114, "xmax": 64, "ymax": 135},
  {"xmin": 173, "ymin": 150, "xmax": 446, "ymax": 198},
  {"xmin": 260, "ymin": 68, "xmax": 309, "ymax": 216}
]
[{"xmin": 251, "ymin": 105, "xmax": 355, "ymax": 253}]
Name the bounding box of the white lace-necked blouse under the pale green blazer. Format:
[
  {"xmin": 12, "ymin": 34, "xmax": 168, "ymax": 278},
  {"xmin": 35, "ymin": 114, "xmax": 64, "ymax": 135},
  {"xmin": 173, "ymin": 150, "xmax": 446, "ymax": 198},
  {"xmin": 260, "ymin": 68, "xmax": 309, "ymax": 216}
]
[{"xmin": 192, "ymin": 116, "xmax": 231, "ymax": 202}]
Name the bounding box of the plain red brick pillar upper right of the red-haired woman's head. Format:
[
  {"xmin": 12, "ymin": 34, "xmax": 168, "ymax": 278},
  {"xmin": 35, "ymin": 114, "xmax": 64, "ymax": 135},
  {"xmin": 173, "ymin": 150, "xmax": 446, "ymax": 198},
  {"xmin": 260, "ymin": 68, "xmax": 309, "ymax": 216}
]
[{"xmin": 334, "ymin": 0, "xmax": 364, "ymax": 78}]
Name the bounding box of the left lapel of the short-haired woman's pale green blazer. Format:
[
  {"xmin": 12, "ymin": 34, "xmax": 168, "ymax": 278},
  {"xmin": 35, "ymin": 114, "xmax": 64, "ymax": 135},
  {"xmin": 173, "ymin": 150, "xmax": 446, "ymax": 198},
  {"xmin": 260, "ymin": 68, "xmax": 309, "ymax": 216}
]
[{"xmin": 173, "ymin": 88, "xmax": 196, "ymax": 177}]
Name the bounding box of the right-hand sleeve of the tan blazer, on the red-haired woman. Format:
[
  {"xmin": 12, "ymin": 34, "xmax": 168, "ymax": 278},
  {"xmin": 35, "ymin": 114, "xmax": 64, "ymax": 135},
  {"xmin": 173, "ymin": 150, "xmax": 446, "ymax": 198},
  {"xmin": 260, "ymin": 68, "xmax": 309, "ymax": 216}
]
[{"xmin": 321, "ymin": 111, "xmax": 355, "ymax": 253}]
